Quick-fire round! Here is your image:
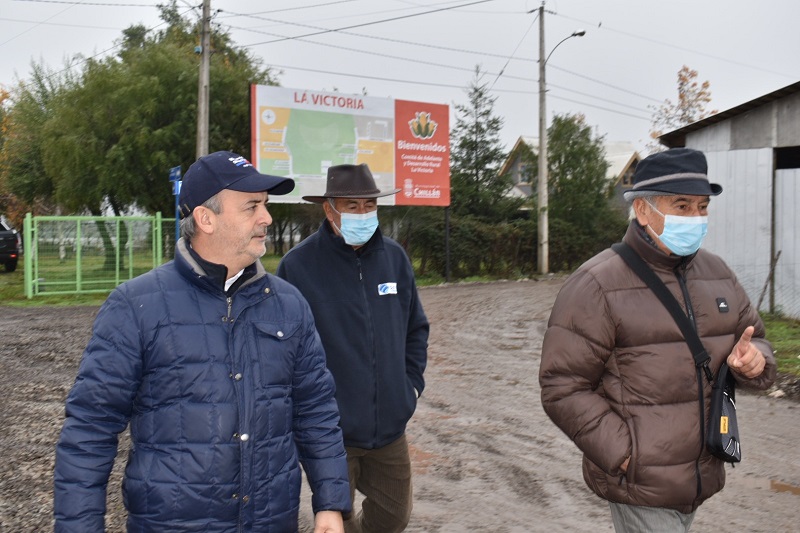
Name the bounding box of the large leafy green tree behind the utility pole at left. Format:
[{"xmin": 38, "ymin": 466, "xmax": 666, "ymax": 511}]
[{"xmin": 3, "ymin": 1, "xmax": 274, "ymax": 220}]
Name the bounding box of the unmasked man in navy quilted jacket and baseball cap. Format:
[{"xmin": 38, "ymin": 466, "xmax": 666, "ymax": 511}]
[{"xmin": 54, "ymin": 152, "xmax": 351, "ymax": 533}]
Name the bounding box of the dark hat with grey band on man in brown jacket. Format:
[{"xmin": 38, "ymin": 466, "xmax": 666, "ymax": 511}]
[{"xmin": 622, "ymin": 148, "xmax": 722, "ymax": 202}]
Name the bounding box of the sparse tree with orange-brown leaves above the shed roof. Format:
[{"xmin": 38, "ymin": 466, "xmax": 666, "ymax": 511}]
[{"xmin": 648, "ymin": 65, "xmax": 717, "ymax": 151}]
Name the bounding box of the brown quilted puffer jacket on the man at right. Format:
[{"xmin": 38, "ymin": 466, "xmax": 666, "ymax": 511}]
[{"xmin": 539, "ymin": 221, "xmax": 775, "ymax": 513}]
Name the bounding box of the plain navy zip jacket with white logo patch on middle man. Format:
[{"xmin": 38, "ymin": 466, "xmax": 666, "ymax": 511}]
[{"xmin": 276, "ymin": 220, "xmax": 430, "ymax": 450}]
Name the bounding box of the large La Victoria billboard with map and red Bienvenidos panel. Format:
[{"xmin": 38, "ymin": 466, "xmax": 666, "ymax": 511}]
[{"xmin": 251, "ymin": 85, "xmax": 450, "ymax": 206}]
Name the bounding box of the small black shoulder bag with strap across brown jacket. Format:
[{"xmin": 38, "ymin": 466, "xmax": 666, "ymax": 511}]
[{"xmin": 611, "ymin": 242, "xmax": 742, "ymax": 463}]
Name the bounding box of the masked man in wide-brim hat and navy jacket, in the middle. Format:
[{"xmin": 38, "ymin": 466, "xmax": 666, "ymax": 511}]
[{"xmin": 277, "ymin": 164, "xmax": 428, "ymax": 533}]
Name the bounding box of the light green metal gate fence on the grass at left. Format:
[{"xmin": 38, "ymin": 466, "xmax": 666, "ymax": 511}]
[{"xmin": 24, "ymin": 213, "xmax": 175, "ymax": 298}]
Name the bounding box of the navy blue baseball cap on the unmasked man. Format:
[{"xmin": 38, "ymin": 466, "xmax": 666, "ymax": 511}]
[{"xmin": 178, "ymin": 151, "xmax": 294, "ymax": 218}]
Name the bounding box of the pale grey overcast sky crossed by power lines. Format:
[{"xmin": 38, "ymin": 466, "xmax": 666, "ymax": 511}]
[{"xmin": 0, "ymin": 0, "xmax": 800, "ymax": 154}]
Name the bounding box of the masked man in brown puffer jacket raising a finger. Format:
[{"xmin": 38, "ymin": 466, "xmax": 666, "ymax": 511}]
[{"xmin": 539, "ymin": 148, "xmax": 775, "ymax": 532}]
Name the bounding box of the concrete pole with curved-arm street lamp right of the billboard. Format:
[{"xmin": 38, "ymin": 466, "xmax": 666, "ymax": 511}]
[{"xmin": 537, "ymin": 3, "xmax": 586, "ymax": 274}]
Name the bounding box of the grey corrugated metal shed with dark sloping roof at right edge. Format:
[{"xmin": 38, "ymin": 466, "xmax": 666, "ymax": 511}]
[{"xmin": 659, "ymin": 82, "xmax": 800, "ymax": 319}]
